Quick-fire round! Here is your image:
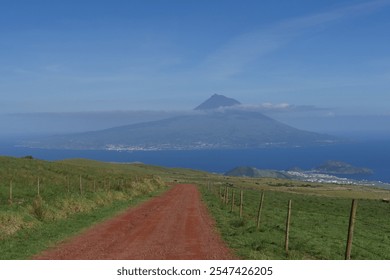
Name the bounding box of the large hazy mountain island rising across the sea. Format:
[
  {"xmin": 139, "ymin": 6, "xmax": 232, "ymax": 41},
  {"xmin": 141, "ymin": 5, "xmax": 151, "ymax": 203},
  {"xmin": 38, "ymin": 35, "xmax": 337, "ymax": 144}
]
[{"xmin": 27, "ymin": 94, "xmax": 338, "ymax": 150}]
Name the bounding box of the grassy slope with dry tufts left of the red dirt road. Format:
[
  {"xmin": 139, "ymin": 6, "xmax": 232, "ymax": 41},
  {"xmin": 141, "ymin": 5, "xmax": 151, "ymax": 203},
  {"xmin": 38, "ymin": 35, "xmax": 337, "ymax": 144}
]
[{"xmin": 0, "ymin": 157, "xmax": 171, "ymax": 259}]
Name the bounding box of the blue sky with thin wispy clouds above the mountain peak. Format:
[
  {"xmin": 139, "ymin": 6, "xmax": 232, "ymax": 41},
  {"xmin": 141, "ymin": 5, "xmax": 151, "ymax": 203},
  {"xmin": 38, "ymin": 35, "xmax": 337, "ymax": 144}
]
[{"xmin": 0, "ymin": 0, "xmax": 390, "ymax": 116}]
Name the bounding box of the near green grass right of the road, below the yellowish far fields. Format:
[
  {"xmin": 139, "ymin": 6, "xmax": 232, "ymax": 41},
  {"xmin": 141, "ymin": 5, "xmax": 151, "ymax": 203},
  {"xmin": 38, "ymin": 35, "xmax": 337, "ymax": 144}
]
[{"xmin": 200, "ymin": 184, "xmax": 390, "ymax": 260}]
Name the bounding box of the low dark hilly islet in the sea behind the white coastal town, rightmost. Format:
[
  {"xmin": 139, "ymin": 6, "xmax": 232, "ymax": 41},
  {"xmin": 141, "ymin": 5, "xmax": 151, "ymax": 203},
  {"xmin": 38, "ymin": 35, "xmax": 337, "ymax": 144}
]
[{"xmin": 313, "ymin": 160, "xmax": 373, "ymax": 175}]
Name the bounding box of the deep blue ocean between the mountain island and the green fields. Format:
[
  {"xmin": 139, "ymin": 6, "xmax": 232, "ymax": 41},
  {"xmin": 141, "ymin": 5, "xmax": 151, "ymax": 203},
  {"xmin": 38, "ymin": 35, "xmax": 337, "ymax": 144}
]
[{"xmin": 0, "ymin": 141, "xmax": 390, "ymax": 183}]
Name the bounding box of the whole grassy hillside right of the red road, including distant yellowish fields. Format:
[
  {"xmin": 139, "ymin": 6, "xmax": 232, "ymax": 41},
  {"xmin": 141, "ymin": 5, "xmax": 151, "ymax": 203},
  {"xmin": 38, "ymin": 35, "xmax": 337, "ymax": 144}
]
[{"xmin": 145, "ymin": 164, "xmax": 390, "ymax": 260}]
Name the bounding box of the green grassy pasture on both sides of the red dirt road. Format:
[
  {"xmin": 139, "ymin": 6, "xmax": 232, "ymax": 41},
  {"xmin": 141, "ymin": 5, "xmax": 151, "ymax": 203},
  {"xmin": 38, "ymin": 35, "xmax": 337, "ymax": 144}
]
[{"xmin": 0, "ymin": 157, "xmax": 390, "ymax": 259}]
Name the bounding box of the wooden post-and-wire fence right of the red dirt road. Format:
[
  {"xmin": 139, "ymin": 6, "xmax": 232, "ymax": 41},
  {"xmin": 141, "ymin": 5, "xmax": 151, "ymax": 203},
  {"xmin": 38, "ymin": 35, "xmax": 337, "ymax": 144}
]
[{"xmin": 205, "ymin": 182, "xmax": 390, "ymax": 259}]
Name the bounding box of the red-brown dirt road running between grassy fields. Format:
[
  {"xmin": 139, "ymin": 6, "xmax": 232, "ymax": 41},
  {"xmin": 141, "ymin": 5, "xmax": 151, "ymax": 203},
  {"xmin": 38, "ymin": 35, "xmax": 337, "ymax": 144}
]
[{"xmin": 35, "ymin": 185, "xmax": 235, "ymax": 260}]
